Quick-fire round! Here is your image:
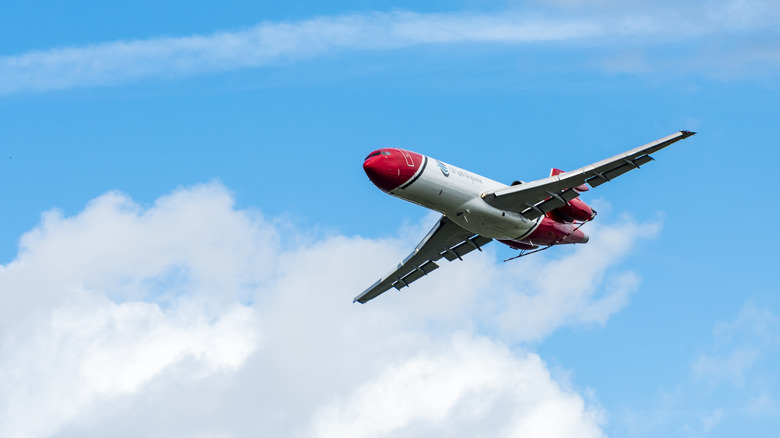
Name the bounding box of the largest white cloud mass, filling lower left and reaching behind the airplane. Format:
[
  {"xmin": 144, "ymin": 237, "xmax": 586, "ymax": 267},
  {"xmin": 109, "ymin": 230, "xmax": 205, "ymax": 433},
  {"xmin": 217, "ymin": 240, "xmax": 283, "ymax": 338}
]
[{"xmin": 0, "ymin": 184, "xmax": 656, "ymax": 437}]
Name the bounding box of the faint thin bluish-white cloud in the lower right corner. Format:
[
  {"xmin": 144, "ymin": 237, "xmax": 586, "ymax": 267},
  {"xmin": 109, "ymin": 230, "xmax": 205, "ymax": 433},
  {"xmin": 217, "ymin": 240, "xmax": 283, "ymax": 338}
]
[{"xmin": 611, "ymin": 301, "xmax": 780, "ymax": 436}]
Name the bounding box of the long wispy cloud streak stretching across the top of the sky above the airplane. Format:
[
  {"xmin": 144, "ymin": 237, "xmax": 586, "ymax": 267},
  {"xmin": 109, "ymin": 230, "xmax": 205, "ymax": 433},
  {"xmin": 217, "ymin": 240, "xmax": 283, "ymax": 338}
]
[{"xmin": 0, "ymin": 0, "xmax": 780, "ymax": 94}]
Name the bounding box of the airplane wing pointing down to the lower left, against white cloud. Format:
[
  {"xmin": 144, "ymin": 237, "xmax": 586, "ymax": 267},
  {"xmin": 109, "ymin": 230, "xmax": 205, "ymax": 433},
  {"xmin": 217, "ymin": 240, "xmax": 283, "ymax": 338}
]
[{"xmin": 352, "ymin": 216, "xmax": 493, "ymax": 304}]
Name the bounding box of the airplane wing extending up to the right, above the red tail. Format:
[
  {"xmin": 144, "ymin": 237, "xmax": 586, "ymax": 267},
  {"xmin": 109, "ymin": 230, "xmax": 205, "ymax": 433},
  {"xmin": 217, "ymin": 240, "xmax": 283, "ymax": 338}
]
[{"xmin": 482, "ymin": 131, "xmax": 695, "ymax": 219}]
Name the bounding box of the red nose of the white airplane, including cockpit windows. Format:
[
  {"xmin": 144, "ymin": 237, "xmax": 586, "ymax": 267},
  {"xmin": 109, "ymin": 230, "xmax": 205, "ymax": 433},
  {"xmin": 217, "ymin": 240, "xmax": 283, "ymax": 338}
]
[{"xmin": 363, "ymin": 149, "xmax": 423, "ymax": 192}]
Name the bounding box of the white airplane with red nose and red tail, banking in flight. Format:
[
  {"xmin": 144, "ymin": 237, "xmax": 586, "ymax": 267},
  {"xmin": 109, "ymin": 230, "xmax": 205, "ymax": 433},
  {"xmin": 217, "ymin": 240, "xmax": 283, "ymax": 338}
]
[{"xmin": 352, "ymin": 131, "xmax": 696, "ymax": 304}]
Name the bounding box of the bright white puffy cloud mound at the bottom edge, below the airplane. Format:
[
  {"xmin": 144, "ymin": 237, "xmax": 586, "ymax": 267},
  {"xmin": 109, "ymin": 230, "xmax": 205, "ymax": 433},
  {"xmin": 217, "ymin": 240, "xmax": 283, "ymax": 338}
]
[{"xmin": 312, "ymin": 336, "xmax": 602, "ymax": 437}]
